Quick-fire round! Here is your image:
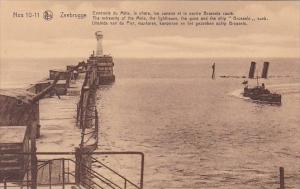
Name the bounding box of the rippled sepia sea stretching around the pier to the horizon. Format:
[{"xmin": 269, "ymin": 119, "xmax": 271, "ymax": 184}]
[{"xmin": 0, "ymin": 58, "xmax": 300, "ymax": 189}]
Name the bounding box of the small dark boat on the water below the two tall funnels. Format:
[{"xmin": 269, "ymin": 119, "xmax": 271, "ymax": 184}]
[{"xmin": 243, "ymin": 84, "xmax": 281, "ymax": 105}]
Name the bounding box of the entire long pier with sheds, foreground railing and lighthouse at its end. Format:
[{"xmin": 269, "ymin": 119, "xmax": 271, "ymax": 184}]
[{"xmin": 0, "ymin": 32, "xmax": 144, "ymax": 189}]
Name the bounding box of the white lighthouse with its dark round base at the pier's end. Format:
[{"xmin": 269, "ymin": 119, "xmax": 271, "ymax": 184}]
[{"xmin": 87, "ymin": 31, "xmax": 115, "ymax": 85}]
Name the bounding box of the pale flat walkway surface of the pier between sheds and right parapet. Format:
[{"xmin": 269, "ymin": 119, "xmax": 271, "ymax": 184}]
[{"xmin": 37, "ymin": 74, "xmax": 84, "ymax": 151}]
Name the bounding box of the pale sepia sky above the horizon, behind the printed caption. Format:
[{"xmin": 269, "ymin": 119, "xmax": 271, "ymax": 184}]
[{"xmin": 0, "ymin": 0, "xmax": 300, "ymax": 58}]
